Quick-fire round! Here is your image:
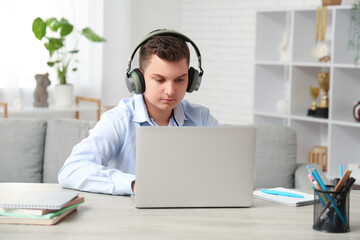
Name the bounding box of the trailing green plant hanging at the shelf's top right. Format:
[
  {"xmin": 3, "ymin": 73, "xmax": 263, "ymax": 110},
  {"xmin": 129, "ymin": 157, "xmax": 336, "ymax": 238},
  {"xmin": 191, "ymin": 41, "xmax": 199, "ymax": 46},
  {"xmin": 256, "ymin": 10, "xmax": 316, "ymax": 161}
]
[{"xmin": 348, "ymin": 0, "xmax": 360, "ymax": 65}]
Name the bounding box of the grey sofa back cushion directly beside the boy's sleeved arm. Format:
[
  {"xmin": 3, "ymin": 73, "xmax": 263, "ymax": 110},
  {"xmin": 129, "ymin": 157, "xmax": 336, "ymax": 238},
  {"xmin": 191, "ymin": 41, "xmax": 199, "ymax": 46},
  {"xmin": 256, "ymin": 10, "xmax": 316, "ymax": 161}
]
[{"xmin": 43, "ymin": 118, "xmax": 96, "ymax": 183}]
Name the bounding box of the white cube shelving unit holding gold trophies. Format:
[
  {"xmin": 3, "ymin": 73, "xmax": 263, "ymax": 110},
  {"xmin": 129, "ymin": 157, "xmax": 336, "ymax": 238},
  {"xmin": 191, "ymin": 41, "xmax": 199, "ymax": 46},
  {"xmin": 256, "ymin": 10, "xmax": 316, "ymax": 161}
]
[{"xmin": 254, "ymin": 6, "xmax": 360, "ymax": 178}]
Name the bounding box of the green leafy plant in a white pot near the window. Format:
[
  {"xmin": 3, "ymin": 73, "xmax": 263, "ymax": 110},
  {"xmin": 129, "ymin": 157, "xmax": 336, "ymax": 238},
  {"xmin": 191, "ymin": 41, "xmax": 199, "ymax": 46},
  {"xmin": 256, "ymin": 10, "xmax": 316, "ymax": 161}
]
[{"xmin": 32, "ymin": 17, "xmax": 105, "ymax": 106}]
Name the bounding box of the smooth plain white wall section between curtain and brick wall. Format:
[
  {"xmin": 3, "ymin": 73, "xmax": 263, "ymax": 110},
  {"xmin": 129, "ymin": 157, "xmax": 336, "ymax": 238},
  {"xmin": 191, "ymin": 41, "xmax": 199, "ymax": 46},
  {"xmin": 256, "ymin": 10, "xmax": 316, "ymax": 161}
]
[{"xmin": 102, "ymin": 0, "xmax": 181, "ymax": 106}]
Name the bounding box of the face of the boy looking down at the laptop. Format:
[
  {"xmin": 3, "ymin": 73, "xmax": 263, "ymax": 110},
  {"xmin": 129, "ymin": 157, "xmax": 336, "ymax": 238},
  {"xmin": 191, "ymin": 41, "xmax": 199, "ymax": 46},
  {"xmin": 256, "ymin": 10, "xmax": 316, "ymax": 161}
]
[{"xmin": 142, "ymin": 54, "xmax": 188, "ymax": 118}]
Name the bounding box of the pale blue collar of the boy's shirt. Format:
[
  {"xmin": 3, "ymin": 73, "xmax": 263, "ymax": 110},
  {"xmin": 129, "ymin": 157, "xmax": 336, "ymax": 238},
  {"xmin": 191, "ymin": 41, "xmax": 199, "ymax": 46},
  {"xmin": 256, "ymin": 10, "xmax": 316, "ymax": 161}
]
[{"xmin": 133, "ymin": 94, "xmax": 187, "ymax": 126}]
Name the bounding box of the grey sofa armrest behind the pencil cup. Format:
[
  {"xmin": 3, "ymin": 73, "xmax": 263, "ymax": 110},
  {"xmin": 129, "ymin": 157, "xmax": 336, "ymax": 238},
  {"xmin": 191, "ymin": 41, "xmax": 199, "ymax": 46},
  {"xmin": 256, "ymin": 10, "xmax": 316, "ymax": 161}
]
[{"xmin": 294, "ymin": 163, "xmax": 330, "ymax": 189}]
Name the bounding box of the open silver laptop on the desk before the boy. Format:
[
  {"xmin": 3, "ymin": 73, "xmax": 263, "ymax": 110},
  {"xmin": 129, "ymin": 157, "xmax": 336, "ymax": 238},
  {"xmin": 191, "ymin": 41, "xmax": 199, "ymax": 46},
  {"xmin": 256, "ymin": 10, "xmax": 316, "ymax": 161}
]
[{"xmin": 134, "ymin": 126, "xmax": 256, "ymax": 208}]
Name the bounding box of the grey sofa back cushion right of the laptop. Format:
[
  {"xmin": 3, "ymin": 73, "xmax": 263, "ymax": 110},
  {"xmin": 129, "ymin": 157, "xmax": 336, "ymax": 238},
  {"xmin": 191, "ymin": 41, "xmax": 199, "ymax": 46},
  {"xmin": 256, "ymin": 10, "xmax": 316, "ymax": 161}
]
[{"xmin": 255, "ymin": 126, "xmax": 297, "ymax": 188}]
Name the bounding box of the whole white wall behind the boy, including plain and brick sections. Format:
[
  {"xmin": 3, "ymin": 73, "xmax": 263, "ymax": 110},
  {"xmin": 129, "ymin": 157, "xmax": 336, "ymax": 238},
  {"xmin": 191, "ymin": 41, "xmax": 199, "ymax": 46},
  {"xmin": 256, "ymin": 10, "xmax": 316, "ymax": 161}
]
[{"xmin": 102, "ymin": 0, "xmax": 321, "ymax": 124}]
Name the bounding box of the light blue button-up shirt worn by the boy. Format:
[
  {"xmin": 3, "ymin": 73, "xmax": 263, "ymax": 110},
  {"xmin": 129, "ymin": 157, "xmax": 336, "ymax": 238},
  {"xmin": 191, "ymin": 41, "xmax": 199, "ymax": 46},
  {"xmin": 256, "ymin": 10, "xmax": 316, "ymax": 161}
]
[{"xmin": 58, "ymin": 94, "xmax": 219, "ymax": 195}]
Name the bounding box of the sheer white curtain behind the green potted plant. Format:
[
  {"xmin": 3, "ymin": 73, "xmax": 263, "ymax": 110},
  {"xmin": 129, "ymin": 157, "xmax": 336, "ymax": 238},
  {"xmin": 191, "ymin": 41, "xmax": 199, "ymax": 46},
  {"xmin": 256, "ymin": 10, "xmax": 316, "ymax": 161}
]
[{"xmin": 0, "ymin": 0, "xmax": 106, "ymax": 106}]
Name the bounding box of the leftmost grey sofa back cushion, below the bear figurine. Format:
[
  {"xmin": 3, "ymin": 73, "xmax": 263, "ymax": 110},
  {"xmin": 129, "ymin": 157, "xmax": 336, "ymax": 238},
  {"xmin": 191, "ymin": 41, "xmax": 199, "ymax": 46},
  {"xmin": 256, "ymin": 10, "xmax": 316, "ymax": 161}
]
[{"xmin": 0, "ymin": 118, "xmax": 46, "ymax": 182}]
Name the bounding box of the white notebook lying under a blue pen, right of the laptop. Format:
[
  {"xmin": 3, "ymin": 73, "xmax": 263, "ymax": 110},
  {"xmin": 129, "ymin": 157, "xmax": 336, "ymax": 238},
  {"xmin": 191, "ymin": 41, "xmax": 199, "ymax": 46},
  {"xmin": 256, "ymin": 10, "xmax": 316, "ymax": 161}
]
[{"xmin": 254, "ymin": 187, "xmax": 314, "ymax": 207}]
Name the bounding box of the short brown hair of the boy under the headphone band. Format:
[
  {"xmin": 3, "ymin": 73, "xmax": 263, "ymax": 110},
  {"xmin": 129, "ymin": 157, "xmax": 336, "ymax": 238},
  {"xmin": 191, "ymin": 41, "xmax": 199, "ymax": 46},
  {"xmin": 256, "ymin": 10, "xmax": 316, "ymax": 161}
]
[{"xmin": 139, "ymin": 32, "xmax": 190, "ymax": 70}]
